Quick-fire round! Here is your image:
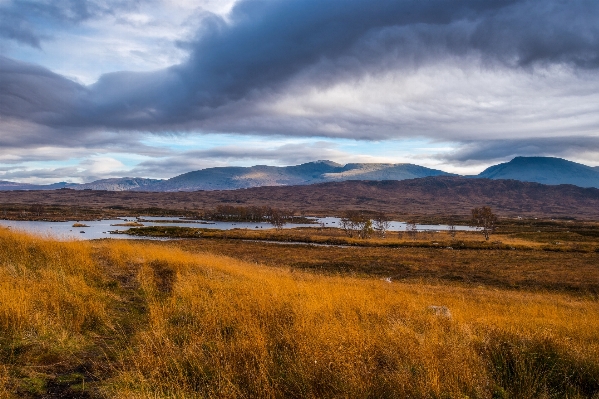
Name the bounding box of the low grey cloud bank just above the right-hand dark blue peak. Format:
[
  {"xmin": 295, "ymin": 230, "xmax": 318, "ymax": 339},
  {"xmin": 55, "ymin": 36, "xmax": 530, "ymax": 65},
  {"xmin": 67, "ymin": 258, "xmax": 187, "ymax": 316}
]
[{"xmin": 439, "ymin": 136, "xmax": 599, "ymax": 162}]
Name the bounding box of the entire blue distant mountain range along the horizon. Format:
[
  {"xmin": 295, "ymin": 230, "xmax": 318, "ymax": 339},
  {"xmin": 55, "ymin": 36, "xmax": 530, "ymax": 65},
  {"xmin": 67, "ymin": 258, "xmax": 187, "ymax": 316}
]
[{"xmin": 0, "ymin": 157, "xmax": 599, "ymax": 192}]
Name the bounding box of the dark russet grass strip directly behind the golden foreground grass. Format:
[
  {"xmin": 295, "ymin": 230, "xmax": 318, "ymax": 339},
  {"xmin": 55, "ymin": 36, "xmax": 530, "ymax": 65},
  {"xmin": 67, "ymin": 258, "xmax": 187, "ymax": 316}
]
[{"xmin": 175, "ymin": 239, "xmax": 599, "ymax": 298}]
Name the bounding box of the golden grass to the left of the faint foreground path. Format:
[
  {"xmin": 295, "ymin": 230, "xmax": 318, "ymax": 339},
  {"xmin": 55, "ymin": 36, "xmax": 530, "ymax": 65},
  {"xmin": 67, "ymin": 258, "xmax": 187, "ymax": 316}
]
[{"xmin": 0, "ymin": 229, "xmax": 112, "ymax": 392}]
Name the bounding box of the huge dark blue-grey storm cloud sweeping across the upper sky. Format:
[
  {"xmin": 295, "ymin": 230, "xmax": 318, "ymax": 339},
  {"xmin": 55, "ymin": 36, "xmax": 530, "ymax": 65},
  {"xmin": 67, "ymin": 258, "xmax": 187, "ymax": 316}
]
[{"xmin": 0, "ymin": 0, "xmax": 599, "ymax": 143}]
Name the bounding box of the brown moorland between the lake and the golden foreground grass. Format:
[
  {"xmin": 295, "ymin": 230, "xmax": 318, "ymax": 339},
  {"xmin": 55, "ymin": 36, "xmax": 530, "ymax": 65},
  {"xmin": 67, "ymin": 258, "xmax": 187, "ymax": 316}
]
[{"xmin": 123, "ymin": 220, "xmax": 599, "ymax": 297}]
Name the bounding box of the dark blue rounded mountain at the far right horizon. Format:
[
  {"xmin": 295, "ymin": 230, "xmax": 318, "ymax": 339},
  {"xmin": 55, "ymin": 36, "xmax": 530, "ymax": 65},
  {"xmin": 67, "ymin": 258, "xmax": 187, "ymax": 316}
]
[{"xmin": 476, "ymin": 157, "xmax": 599, "ymax": 188}]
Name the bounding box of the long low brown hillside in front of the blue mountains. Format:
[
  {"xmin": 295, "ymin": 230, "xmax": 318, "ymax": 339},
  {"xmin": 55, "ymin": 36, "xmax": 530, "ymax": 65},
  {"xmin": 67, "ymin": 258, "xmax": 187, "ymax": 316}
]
[{"xmin": 0, "ymin": 176, "xmax": 599, "ymax": 220}]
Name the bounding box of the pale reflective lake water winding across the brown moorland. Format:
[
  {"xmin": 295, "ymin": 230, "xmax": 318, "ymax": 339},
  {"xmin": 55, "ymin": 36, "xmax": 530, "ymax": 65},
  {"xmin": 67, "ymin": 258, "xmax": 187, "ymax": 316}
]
[{"xmin": 0, "ymin": 216, "xmax": 475, "ymax": 240}]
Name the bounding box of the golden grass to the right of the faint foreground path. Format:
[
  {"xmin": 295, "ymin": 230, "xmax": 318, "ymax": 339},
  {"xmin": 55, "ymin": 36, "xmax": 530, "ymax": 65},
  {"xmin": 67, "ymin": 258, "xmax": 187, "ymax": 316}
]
[{"xmin": 106, "ymin": 248, "xmax": 599, "ymax": 397}]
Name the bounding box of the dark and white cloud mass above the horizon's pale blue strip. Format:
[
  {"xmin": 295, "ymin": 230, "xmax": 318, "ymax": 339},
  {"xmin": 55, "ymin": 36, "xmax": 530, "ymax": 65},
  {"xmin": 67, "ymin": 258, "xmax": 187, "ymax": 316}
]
[{"xmin": 0, "ymin": 0, "xmax": 599, "ymax": 181}]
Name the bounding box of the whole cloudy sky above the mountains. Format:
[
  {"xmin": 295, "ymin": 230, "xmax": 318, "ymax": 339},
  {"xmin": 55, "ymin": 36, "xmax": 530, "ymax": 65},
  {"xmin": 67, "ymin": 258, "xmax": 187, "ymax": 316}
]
[{"xmin": 0, "ymin": 0, "xmax": 599, "ymax": 183}]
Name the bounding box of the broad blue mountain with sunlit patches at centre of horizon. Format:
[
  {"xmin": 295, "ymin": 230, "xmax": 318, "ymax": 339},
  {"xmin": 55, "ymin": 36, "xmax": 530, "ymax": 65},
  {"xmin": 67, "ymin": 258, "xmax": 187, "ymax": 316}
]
[{"xmin": 145, "ymin": 161, "xmax": 449, "ymax": 191}]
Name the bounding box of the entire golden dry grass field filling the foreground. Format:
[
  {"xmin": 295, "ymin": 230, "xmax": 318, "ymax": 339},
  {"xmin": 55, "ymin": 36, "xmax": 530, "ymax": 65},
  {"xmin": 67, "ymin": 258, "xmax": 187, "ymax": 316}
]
[{"xmin": 0, "ymin": 229, "xmax": 599, "ymax": 398}]
